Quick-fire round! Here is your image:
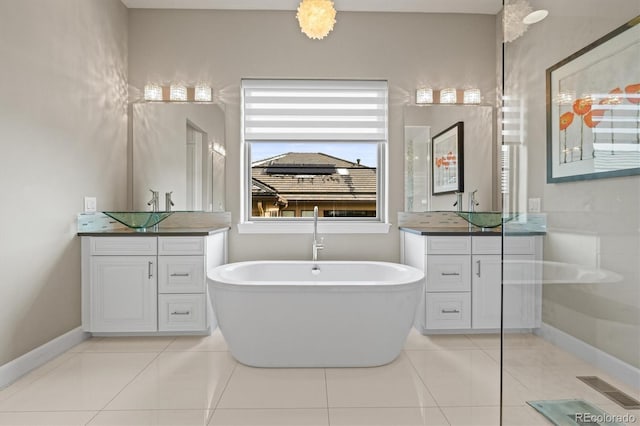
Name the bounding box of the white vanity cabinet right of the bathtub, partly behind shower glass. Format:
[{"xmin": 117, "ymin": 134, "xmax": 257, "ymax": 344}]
[{"xmin": 401, "ymin": 231, "xmax": 542, "ymax": 334}]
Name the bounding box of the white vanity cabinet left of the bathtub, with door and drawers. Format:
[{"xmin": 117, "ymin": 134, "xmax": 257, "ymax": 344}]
[{"xmin": 82, "ymin": 232, "xmax": 226, "ymax": 334}]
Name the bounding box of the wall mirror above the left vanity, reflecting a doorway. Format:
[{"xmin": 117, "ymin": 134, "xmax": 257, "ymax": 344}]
[{"xmin": 133, "ymin": 103, "xmax": 225, "ymax": 211}]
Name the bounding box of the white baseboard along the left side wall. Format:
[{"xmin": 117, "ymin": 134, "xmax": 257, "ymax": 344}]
[{"xmin": 0, "ymin": 327, "xmax": 89, "ymax": 389}]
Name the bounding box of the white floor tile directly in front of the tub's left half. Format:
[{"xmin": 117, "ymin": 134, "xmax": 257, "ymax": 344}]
[{"xmin": 218, "ymin": 364, "xmax": 327, "ymax": 408}]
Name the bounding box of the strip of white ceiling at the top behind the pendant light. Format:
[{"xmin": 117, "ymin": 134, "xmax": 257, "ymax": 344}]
[{"xmin": 121, "ymin": 0, "xmax": 502, "ymax": 15}]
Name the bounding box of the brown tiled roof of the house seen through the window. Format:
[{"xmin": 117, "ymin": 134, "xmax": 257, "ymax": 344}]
[{"xmin": 252, "ymin": 152, "xmax": 376, "ymax": 201}]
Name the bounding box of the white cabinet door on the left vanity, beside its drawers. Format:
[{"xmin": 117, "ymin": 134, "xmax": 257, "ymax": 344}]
[{"xmin": 87, "ymin": 256, "xmax": 157, "ymax": 332}]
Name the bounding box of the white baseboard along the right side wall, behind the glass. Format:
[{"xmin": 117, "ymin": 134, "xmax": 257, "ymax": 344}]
[{"xmin": 534, "ymin": 323, "xmax": 640, "ymax": 389}]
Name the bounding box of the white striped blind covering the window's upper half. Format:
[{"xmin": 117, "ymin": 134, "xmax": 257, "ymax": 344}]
[{"xmin": 242, "ymin": 80, "xmax": 388, "ymax": 142}]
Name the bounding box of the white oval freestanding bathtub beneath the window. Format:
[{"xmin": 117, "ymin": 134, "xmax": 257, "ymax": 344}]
[{"xmin": 208, "ymin": 261, "xmax": 424, "ymax": 367}]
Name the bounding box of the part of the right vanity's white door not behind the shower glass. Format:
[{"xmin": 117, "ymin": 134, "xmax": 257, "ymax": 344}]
[{"xmin": 471, "ymin": 254, "xmax": 502, "ymax": 329}]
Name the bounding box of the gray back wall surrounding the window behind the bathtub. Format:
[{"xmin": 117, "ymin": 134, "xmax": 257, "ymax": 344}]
[{"xmin": 129, "ymin": 10, "xmax": 496, "ymax": 261}]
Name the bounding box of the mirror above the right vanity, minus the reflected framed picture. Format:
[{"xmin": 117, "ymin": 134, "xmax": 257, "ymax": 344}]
[{"xmin": 403, "ymin": 105, "xmax": 499, "ymax": 212}]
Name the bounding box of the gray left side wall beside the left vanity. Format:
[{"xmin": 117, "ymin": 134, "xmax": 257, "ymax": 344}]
[{"xmin": 0, "ymin": 0, "xmax": 127, "ymax": 365}]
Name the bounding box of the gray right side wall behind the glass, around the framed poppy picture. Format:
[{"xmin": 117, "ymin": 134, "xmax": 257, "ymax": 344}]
[{"xmin": 505, "ymin": 0, "xmax": 640, "ymax": 367}]
